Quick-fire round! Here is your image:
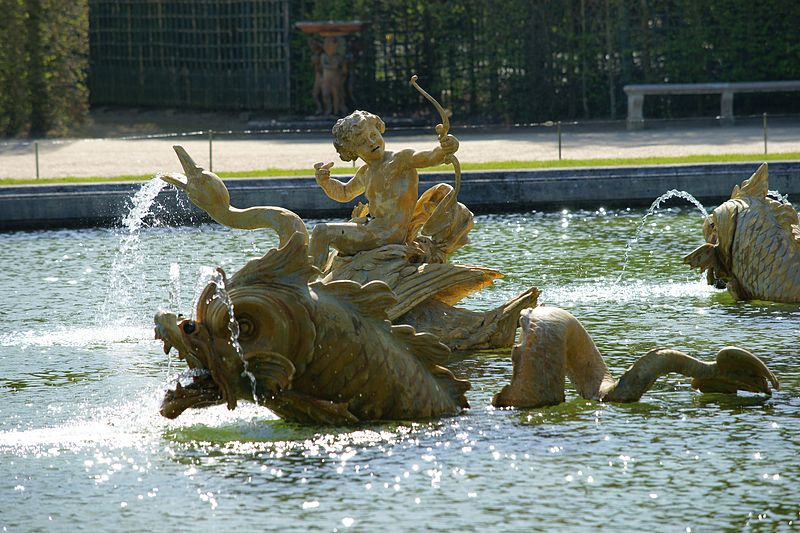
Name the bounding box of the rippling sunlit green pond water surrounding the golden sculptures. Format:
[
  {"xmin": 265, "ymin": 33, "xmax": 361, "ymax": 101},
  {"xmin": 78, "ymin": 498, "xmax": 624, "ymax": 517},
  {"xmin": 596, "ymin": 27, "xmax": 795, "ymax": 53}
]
[{"xmin": 0, "ymin": 189, "xmax": 800, "ymax": 531}]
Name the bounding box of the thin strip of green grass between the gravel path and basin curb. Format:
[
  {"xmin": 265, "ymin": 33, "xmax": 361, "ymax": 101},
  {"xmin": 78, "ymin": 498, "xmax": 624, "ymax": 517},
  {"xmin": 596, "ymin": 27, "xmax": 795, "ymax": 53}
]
[{"xmin": 0, "ymin": 152, "xmax": 800, "ymax": 186}]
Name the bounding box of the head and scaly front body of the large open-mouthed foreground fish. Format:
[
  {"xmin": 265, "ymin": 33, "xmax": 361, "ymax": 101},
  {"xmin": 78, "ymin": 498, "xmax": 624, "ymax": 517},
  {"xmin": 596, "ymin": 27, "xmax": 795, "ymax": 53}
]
[{"xmin": 155, "ymin": 233, "xmax": 469, "ymax": 424}]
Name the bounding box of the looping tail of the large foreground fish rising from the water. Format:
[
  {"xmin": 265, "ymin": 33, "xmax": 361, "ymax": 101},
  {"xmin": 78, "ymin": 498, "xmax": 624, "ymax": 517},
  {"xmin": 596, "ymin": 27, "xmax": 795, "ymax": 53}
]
[{"xmin": 492, "ymin": 307, "xmax": 779, "ymax": 407}]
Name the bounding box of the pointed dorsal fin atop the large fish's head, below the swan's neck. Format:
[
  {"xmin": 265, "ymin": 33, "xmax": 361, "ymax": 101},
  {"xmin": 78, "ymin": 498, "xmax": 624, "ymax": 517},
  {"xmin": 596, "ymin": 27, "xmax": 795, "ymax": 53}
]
[{"xmin": 230, "ymin": 232, "xmax": 320, "ymax": 287}]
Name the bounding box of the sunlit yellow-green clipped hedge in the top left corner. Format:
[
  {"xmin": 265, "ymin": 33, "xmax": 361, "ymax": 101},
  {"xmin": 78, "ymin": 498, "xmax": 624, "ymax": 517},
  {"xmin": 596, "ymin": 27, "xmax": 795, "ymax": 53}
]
[{"xmin": 0, "ymin": 0, "xmax": 89, "ymax": 136}]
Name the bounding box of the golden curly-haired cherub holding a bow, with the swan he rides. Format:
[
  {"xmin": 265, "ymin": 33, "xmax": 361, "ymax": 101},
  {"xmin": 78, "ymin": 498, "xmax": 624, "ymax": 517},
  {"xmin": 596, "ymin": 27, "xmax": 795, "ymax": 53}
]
[{"xmin": 161, "ymin": 79, "xmax": 538, "ymax": 350}]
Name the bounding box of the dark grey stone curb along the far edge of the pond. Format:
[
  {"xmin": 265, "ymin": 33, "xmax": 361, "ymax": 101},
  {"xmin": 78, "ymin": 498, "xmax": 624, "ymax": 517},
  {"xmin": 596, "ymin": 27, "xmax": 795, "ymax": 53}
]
[{"xmin": 0, "ymin": 162, "xmax": 800, "ymax": 231}]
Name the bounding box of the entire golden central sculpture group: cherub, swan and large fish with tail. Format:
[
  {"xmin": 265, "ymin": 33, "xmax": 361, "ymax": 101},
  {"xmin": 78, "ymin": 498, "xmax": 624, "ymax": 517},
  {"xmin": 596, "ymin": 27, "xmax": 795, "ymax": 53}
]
[{"xmin": 150, "ymin": 76, "xmax": 778, "ymax": 424}]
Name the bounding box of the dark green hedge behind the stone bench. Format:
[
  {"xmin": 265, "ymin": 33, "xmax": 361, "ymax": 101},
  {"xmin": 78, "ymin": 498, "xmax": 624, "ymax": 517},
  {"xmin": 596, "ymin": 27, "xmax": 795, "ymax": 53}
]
[{"xmin": 304, "ymin": 0, "xmax": 800, "ymax": 122}]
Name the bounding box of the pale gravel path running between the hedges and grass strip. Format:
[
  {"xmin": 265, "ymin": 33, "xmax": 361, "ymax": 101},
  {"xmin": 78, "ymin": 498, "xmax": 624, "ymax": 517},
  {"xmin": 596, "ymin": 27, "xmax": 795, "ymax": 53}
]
[{"xmin": 0, "ymin": 120, "xmax": 800, "ymax": 179}]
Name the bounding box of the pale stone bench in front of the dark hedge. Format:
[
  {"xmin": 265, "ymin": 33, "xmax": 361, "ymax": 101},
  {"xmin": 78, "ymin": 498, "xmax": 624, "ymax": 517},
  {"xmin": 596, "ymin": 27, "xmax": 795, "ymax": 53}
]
[{"xmin": 622, "ymin": 80, "xmax": 800, "ymax": 130}]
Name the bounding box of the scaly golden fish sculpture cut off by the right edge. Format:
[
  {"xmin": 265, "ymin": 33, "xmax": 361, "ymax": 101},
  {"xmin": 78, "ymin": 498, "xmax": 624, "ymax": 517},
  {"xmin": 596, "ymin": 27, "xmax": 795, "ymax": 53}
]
[{"xmin": 683, "ymin": 163, "xmax": 800, "ymax": 303}]
